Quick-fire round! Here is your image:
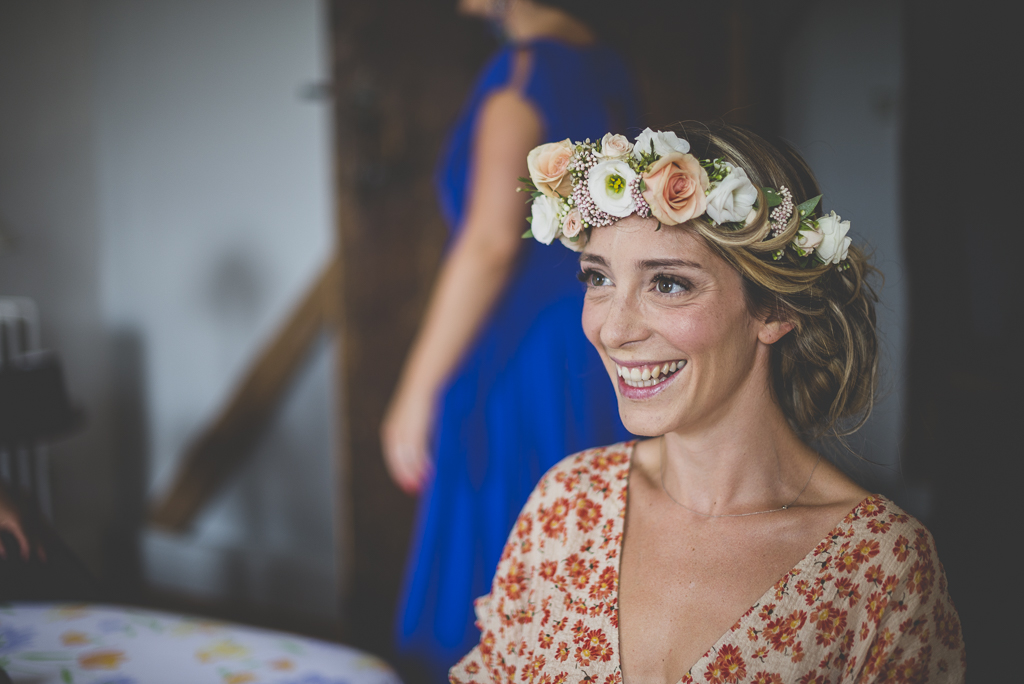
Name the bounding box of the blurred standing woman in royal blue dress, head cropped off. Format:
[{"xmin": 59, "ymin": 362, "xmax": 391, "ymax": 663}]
[{"xmin": 381, "ymin": 0, "xmax": 638, "ymax": 681}]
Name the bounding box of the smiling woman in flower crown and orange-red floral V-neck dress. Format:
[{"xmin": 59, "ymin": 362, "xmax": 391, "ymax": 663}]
[{"xmin": 451, "ymin": 127, "xmax": 966, "ymax": 684}]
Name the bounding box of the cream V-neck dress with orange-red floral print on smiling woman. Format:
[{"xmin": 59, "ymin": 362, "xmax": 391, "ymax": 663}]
[{"xmin": 450, "ymin": 442, "xmax": 966, "ymax": 684}]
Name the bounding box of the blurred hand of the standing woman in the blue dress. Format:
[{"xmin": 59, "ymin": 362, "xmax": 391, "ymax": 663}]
[{"xmin": 381, "ymin": 388, "xmax": 435, "ymax": 494}]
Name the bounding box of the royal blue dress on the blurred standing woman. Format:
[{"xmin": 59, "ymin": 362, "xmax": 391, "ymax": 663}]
[{"xmin": 396, "ymin": 40, "xmax": 636, "ymax": 682}]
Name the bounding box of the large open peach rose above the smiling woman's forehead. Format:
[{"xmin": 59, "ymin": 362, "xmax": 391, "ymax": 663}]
[{"xmin": 643, "ymin": 152, "xmax": 708, "ymax": 225}]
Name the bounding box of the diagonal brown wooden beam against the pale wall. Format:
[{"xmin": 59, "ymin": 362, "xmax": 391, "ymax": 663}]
[{"xmin": 150, "ymin": 258, "xmax": 338, "ymax": 531}]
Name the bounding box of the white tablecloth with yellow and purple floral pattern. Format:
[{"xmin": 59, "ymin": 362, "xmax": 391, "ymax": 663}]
[{"xmin": 0, "ymin": 603, "xmax": 400, "ymax": 684}]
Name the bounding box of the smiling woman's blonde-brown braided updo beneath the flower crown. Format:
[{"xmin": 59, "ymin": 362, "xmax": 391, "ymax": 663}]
[{"xmin": 680, "ymin": 124, "xmax": 879, "ymax": 438}]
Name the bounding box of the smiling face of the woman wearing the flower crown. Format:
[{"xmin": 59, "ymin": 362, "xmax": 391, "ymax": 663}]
[{"xmin": 580, "ymin": 215, "xmax": 774, "ymax": 436}]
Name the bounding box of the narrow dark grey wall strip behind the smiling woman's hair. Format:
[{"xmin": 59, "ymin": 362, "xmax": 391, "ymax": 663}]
[{"xmin": 783, "ymin": 0, "xmax": 914, "ymax": 504}]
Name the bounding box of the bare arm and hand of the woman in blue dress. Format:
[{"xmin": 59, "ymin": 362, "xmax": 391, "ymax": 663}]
[{"xmin": 381, "ymin": 88, "xmax": 543, "ymax": 493}]
